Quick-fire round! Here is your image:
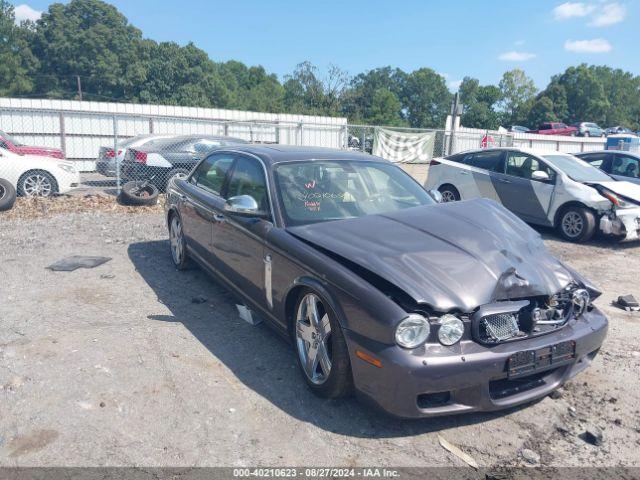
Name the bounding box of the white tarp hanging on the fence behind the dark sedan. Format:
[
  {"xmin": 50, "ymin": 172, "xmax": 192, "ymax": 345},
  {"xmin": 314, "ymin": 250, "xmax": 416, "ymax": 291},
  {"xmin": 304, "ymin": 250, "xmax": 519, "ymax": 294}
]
[{"xmin": 373, "ymin": 127, "xmax": 436, "ymax": 163}]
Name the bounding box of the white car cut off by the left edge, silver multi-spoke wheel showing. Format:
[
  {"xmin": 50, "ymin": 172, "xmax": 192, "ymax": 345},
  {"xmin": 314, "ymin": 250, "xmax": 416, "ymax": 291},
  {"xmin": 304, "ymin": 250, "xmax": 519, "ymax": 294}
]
[{"xmin": 0, "ymin": 149, "xmax": 80, "ymax": 197}]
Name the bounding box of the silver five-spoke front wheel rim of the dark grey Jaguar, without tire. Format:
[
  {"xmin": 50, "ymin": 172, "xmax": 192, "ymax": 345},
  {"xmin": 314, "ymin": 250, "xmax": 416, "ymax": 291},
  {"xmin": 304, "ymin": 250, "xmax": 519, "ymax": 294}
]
[{"xmin": 296, "ymin": 293, "xmax": 332, "ymax": 385}]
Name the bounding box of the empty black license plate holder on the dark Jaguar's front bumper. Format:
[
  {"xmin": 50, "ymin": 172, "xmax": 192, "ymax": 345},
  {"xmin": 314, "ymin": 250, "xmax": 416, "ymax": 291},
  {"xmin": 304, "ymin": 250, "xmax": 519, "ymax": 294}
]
[{"xmin": 507, "ymin": 341, "xmax": 576, "ymax": 378}]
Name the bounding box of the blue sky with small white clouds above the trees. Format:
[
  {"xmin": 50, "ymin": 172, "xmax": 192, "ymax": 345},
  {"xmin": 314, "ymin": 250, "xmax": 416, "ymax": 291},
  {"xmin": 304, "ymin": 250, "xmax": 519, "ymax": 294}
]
[{"xmin": 14, "ymin": 0, "xmax": 640, "ymax": 90}]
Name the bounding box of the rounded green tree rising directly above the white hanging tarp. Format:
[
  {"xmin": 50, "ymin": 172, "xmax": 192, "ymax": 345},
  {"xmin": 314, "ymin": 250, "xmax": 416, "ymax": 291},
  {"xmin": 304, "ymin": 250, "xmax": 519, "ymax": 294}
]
[{"xmin": 400, "ymin": 68, "xmax": 452, "ymax": 128}]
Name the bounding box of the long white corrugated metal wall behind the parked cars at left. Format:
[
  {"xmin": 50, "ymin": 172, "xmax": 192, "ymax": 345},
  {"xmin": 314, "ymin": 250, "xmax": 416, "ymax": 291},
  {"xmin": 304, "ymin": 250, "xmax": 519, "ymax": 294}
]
[{"xmin": 0, "ymin": 98, "xmax": 348, "ymax": 170}]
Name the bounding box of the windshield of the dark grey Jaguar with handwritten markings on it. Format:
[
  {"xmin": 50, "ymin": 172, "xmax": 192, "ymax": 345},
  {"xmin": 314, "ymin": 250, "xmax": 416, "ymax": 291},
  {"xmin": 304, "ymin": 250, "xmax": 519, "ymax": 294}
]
[{"xmin": 275, "ymin": 161, "xmax": 435, "ymax": 225}]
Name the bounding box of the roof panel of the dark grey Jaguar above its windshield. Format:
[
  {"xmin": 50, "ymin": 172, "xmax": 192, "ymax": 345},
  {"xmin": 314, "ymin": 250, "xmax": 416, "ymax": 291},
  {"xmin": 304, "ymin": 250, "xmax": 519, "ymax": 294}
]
[{"xmin": 216, "ymin": 144, "xmax": 387, "ymax": 165}]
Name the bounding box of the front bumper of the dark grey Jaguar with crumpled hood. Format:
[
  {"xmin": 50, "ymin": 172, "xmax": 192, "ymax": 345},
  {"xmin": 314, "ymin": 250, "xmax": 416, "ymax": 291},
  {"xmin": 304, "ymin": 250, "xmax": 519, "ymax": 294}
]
[{"xmin": 346, "ymin": 308, "xmax": 608, "ymax": 418}]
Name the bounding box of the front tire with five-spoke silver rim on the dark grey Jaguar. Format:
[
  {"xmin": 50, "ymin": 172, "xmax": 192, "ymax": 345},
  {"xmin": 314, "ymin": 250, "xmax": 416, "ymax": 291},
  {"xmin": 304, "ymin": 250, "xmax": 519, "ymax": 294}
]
[{"xmin": 291, "ymin": 289, "xmax": 353, "ymax": 398}]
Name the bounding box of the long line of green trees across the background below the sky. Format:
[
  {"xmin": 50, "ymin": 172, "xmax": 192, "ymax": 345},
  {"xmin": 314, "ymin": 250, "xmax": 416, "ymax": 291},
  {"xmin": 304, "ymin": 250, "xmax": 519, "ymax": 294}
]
[{"xmin": 0, "ymin": 0, "xmax": 640, "ymax": 129}]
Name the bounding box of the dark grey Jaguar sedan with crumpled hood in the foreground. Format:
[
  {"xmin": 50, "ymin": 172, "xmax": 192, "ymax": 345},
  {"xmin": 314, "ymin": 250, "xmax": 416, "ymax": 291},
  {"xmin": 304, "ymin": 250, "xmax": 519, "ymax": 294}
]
[{"xmin": 166, "ymin": 145, "xmax": 607, "ymax": 417}]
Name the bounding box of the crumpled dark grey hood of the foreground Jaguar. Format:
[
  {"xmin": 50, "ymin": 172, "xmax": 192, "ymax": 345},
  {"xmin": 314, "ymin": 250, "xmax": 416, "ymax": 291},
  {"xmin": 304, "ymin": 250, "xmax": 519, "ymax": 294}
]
[{"xmin": 287, "ymin": 199, "xmax": 580, "ymax": 312}]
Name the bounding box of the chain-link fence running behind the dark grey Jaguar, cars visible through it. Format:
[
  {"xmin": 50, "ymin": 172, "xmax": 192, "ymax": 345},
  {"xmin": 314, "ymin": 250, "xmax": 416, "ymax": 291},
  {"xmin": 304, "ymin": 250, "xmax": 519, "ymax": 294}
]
[{"xmin": 0, "ymin": 107, "xmax": 513, "ymax": 204}]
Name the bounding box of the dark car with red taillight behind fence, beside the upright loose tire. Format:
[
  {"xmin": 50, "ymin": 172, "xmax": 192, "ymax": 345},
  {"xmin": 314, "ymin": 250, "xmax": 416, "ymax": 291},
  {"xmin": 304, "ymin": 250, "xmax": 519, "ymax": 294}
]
[{"xmin": 122, "ymin": 135, "xmax": 249, "ymax": 190}]
